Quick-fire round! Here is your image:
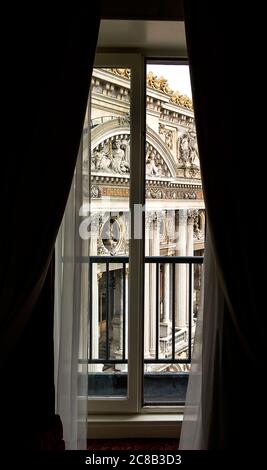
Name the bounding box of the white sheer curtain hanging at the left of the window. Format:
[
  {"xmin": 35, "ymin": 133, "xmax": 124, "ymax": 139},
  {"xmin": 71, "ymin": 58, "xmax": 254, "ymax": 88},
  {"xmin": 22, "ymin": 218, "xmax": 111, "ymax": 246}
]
[{"xmin": 54, "ymin": 112, "xmax": 90, "ymax": 450}]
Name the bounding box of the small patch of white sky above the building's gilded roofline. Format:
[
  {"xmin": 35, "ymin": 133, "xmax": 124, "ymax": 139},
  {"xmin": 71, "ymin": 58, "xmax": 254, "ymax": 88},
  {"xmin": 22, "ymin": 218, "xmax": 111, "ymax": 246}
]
[{"xmin": 147, "ymin": 64, "xmax": 192, "ymax": 99}]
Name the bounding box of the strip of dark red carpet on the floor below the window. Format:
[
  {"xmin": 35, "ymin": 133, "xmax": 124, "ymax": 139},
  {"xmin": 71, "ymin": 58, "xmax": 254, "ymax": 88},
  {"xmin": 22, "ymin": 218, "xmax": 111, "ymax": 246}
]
[{"xmin": 87, "ymin": 439, "xmax": 179, "ymax": 450}]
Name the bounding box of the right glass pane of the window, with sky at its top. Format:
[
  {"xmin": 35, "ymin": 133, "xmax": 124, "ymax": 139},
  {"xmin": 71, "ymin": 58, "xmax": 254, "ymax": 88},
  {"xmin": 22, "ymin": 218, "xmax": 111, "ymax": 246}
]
[{"xmin": 144, "ymin": 63, "xmax": 205, "ymax": 405}]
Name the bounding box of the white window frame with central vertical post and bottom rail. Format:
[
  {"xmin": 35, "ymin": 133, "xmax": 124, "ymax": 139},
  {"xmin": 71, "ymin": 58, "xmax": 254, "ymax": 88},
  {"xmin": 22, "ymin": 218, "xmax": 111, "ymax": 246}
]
[{"xmin": 88, "ymin": 52, "xmax": 184, "ymax": 416}]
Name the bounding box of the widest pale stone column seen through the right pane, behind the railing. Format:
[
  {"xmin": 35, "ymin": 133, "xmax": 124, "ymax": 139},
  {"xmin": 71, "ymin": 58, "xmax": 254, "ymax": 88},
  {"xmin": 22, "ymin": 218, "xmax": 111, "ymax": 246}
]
[{"xmin": 175, "ymin": 209, "xmax": 187, "ymax": 328}]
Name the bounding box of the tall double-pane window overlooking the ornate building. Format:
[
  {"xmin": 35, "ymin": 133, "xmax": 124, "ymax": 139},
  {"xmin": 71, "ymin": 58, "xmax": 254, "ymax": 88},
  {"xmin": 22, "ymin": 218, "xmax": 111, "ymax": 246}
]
[{"xmin": 81, "ymin": 54, "xmax": 205, "ymax": 422}]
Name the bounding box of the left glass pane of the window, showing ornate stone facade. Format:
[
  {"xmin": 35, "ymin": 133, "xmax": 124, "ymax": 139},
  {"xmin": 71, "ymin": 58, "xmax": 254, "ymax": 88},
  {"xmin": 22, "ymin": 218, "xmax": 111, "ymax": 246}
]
[{"xmin": 88, "ymin": 68, "xmax": 131, "ymax": 398}]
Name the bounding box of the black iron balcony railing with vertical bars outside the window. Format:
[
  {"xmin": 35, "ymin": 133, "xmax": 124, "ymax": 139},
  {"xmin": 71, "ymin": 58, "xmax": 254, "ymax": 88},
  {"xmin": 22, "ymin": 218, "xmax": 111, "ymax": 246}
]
[{"xmin": 87, "ymin": 256, "xmax": 203, "ymax": 365}]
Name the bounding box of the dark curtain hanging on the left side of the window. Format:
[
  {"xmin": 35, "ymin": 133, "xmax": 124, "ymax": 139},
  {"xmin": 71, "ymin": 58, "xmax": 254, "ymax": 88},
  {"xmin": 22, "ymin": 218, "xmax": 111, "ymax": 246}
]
[{"xmin": 0, "ymin": 2, "xmax": 100, "ymax": 449}]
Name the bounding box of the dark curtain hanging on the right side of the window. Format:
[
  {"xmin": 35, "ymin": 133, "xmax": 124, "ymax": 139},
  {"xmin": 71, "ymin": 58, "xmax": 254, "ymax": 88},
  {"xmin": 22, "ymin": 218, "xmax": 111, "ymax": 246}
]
[{"xmin": 184, "ymin": 0, "xmax": 266, "ymax": 450}]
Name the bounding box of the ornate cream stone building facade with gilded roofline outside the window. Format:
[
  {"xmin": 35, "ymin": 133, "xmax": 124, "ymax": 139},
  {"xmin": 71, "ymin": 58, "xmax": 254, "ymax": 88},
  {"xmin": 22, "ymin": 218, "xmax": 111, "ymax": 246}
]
[{"xmin": 84, "ymin": 68, "xmax": 205, "ymax": 372}]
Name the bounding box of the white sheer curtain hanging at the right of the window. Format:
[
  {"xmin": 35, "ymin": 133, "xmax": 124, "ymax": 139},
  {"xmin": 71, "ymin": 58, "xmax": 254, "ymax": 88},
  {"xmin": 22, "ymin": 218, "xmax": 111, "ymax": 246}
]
[{"xmin": 179, "ymin": 230, "xmax": 224, "ymax": 450}]
